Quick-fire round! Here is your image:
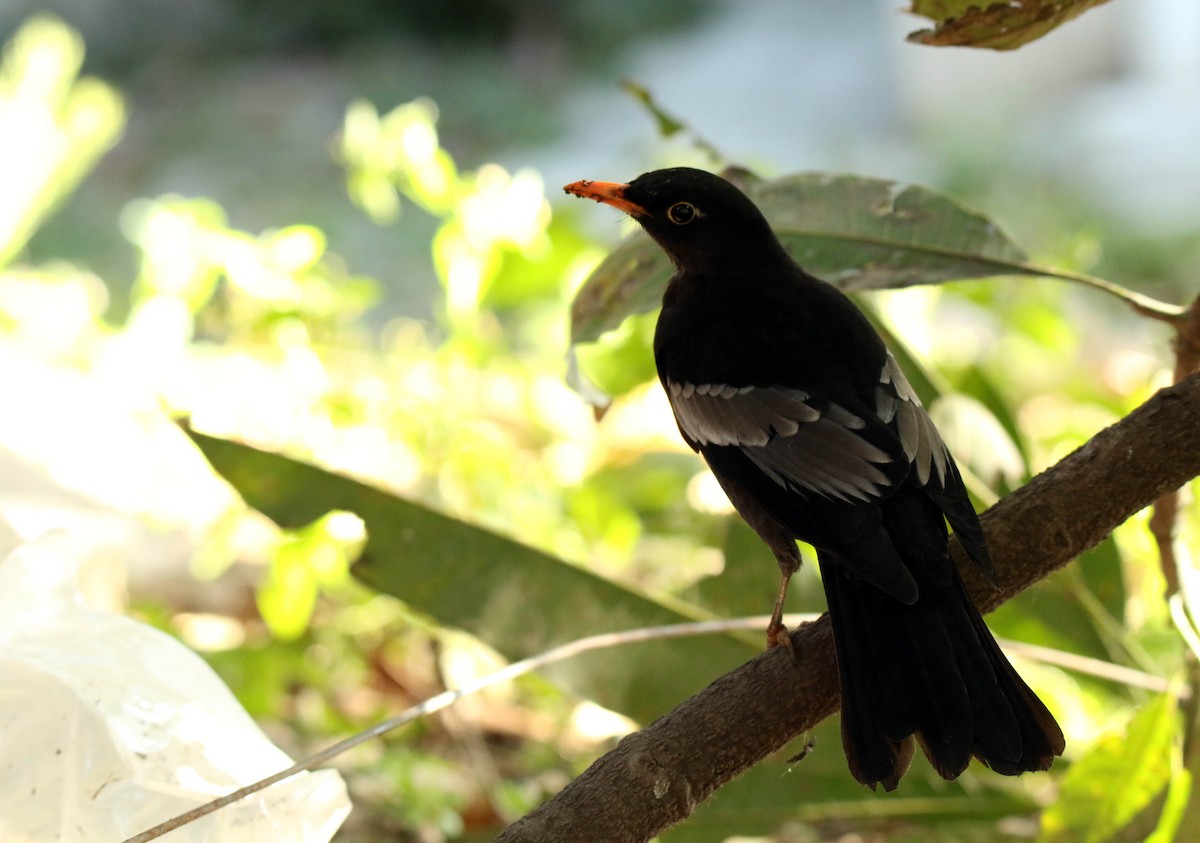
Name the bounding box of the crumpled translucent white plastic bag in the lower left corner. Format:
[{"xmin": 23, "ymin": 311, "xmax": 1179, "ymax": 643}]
[{"xmin": 0, "ymin": 537, "xmax": 350, "ymax": 843}]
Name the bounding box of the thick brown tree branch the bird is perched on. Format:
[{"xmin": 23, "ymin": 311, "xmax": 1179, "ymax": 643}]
[{"xmin": 498, "ymin": 373, "xmax": 1200, "ymax": 843}]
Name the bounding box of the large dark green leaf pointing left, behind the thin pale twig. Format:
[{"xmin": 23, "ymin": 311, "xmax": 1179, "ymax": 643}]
[{"xmin": 188, "ymin": 431, "xmax": 770, "ymax": 721}]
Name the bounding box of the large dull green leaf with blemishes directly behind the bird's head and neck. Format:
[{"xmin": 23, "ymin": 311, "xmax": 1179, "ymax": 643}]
[{"xmin": 571, "ymin": 173, "xmax": 1040, "ymax": 342}]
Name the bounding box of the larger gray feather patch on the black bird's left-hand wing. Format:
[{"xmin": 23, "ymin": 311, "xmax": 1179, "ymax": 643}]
[{"xmin": 667, "ymin": 381, "xmax": 892, "ymax": 501}]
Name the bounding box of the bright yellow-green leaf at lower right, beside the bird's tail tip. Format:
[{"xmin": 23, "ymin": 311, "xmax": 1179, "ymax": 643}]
[{"xmin": 1038, "ymin": 694, "xmax": 1180, "ymax": 843}]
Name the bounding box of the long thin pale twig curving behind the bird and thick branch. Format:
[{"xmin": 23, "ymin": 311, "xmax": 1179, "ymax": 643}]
[{"xmin": 125, "ymin": 614, "xmax": 1169, "ymax": 843}]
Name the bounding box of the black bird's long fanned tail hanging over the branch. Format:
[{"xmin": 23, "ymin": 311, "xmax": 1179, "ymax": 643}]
[{"xmin": 818, "ymin": 490, "xmax": 1064, "ymax": 790}]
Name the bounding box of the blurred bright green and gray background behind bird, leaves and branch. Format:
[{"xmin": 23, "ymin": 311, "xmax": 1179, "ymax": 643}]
[{"xmin": 0, "ymin": 0, "xmax": 1200, "ymax": 842}]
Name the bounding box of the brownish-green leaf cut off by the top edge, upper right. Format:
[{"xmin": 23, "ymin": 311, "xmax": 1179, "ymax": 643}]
[{"xmin": 908, "ymin": 0, "xmax": 1108, "ymax": 49}]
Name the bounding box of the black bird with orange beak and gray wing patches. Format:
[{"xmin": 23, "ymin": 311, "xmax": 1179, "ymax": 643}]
[{"xmin": 565, "ymin": 167, "xmax": 1064, "ymax": 790}]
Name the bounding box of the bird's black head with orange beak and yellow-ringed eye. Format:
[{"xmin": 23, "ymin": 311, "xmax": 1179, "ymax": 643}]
[{"xmin": 563, "ymin": 167, "xmax": 782, "ymax": 274}]
